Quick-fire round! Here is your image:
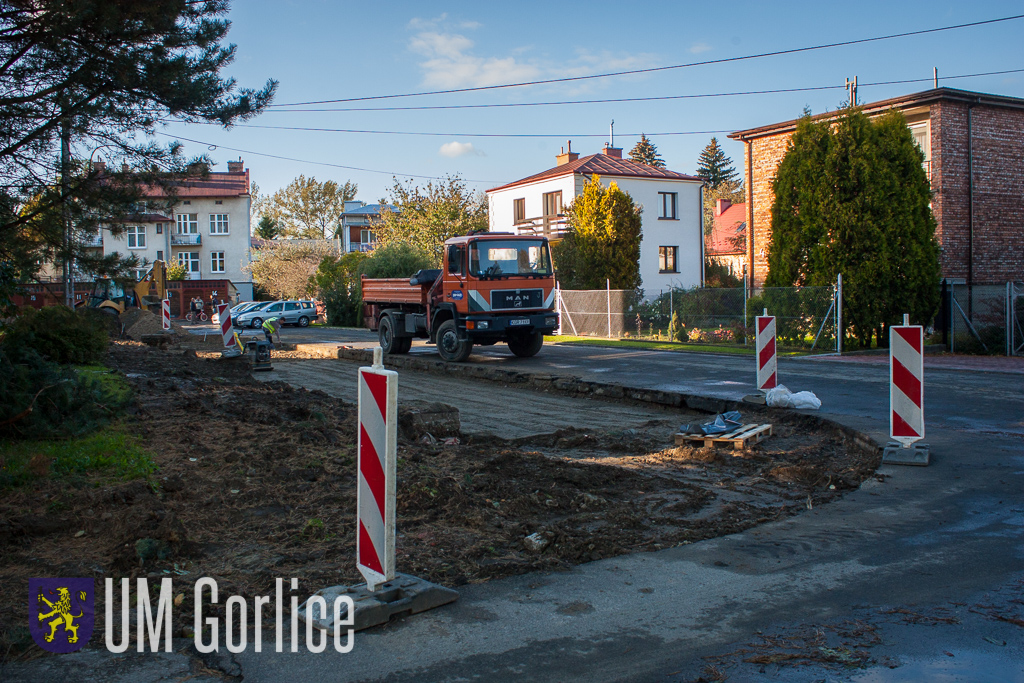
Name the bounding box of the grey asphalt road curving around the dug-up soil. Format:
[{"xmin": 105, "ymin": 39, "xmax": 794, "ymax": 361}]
[{"xmin": 12, "ymin": 328, "xmax": 1011, "ymax": 683}]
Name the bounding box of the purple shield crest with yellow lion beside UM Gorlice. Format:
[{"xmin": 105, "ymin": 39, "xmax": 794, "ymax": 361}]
[{"xmin": 29, "ymin": 579, "xmax": 96, "ymax": 653}]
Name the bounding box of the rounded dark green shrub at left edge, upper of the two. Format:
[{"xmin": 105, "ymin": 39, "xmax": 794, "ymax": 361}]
[{"xmin": 0, "ymin": 306, "xmax": 109, "ymax": 365}]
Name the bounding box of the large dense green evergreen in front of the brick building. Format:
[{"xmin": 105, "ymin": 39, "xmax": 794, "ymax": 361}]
[{"xmin": 765, "ymin": 109, "xmax": 940, "ymax": 347}]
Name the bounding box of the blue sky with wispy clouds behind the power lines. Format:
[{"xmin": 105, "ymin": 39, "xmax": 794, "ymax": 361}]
[{"xmin": 155, "ymin": 0, "xmax": 1024, "ymax": 202}]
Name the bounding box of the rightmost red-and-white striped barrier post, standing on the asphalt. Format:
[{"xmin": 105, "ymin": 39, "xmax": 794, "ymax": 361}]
[{"xmin": 889, "ymin": 315, "xmax": 925, "ymax": 447}]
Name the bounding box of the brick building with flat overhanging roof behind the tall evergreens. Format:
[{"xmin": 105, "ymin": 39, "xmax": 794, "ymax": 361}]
[{"xmin": 729, "ymin": 88, "xmax": 1024, "ymax": 285}]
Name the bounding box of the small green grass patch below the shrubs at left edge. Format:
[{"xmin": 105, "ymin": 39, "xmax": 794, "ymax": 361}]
[{"xmin": 0, "ymin": 425, "xmax": 157, "ymax": 488}]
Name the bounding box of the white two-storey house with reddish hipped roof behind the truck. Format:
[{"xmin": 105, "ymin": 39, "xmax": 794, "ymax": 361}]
[{"xmin": 487, "ymin": 143, "xmax": 703, "ymax": 296}]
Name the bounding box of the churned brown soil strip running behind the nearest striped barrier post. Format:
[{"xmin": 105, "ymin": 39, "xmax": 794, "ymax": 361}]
[{"xmin": 0, "ymin": 342, "xmax": 878, "ymax": 651}]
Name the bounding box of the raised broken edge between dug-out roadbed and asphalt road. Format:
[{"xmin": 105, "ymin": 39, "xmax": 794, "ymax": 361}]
[{"xmin": 329, "ymin": 347, "xmax": 883, "ymax": 456}]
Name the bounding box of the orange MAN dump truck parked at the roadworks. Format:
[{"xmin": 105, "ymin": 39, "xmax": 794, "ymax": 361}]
[{"xmin": 362, "ymin": 232, "xmax": 558, "ymax": 361}]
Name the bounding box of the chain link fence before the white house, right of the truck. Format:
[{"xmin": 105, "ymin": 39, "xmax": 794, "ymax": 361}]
[{"xmin": 559, "ymin": 287, "xmax": 840, "ymax": 352}]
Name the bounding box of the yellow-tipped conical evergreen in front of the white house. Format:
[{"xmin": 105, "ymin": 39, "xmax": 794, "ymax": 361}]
[{"xmin": 552, "ymin": 175, "xmax": 642, "ymax": 290}]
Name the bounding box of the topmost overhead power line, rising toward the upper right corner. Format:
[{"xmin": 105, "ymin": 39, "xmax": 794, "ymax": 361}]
[{"xmin": 271, "ymin": 14, "xmax": 1024, "ymax": 108}]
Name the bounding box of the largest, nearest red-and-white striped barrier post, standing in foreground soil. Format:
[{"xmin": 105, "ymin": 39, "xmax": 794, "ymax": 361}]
[{"xmin": 355, "ymin": 346, "xmax": 398, "ymax": 591}]
